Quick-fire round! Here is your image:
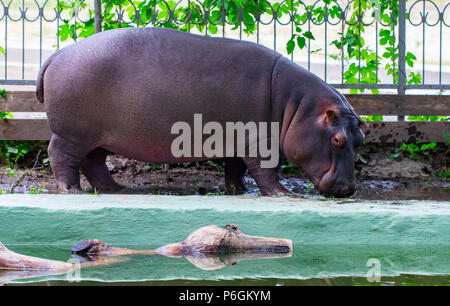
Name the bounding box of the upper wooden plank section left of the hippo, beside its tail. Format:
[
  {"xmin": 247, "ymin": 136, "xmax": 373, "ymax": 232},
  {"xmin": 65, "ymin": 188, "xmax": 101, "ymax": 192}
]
[{"xmin": 0, "ymin": 91, "xmax": 45, "ymax": 112}]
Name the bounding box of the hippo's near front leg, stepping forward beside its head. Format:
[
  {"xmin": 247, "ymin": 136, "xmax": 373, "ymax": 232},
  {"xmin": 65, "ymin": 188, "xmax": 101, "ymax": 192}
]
[{"xmin": 244, "ymin": 157, "xmax": 292, "ymax": 196}]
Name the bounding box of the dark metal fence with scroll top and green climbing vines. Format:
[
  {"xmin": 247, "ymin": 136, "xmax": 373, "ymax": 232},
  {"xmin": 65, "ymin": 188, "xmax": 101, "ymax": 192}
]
[{"xmin": 0, "ymin": 0, "xmax": 450, "ymax": 94}]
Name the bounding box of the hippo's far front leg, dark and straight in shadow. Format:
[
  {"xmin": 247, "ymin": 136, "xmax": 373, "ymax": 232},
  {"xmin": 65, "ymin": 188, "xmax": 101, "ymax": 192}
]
[{"xmin": 225, "ymin": 157, "xmax": 247, "ymax": 194}]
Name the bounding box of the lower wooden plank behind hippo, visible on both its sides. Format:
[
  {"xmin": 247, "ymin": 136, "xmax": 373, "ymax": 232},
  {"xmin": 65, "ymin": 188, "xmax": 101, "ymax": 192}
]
[{"xmin": 0, "ymin": 119, "xmax": 450, "ymax": 143}]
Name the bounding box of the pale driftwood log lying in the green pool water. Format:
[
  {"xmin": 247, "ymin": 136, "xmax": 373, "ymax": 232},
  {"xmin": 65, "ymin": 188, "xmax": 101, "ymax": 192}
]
[{"xmin": 0, "ymin": 224, "xmax": 293, "ymax": 283}]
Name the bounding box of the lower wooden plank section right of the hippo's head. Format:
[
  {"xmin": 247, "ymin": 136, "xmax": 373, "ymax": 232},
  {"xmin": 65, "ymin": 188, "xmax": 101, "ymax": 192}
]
[{"xmin": 364, "ymin": 122, "xmax": 450, "ymax": 143}]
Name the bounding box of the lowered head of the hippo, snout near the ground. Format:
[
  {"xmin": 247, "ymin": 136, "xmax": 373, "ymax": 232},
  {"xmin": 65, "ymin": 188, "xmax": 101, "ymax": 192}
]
[{"xmin": 282, "ymin": 87, "xmax": 365, "ymax": 197}]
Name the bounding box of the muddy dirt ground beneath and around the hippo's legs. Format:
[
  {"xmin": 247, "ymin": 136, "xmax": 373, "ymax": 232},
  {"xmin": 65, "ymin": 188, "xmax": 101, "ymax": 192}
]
[{"xmin": 0, "ymin": 144, "xmax": 450, "ymax": 201}]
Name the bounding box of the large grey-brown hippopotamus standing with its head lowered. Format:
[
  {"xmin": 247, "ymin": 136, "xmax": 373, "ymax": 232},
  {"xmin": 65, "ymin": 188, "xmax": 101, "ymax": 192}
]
[{"xmin": 36, "ymin": 28, "xmax": 364, "ymax": 197}]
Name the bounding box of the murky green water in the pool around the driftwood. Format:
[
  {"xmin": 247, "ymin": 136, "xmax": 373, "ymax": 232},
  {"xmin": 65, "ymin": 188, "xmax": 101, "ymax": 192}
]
[{"xmin": 0, "ymin": 244, "xmax": 450, "ymax": 285}]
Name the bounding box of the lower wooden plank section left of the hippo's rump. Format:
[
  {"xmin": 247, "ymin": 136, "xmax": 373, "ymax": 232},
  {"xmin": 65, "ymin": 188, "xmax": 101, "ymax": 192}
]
[{"xmin": 0, "ymin": 119, "xmax": 52, "ymax": 140}]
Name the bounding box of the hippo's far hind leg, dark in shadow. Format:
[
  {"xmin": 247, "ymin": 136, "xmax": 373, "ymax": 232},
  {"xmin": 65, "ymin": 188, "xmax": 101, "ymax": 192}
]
[{"xmin": 81, "ymin": 148, "xmax": 125, "ymax": 193}]
